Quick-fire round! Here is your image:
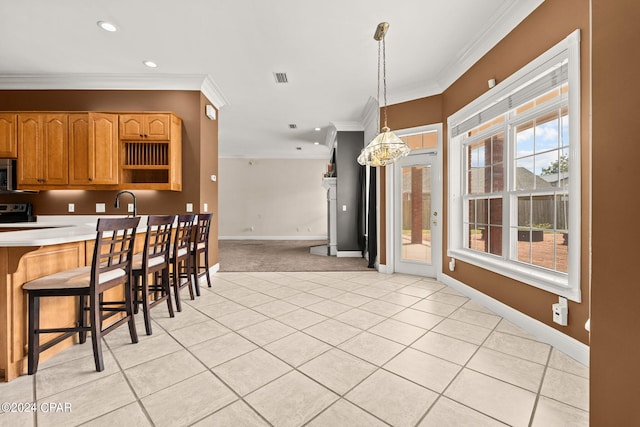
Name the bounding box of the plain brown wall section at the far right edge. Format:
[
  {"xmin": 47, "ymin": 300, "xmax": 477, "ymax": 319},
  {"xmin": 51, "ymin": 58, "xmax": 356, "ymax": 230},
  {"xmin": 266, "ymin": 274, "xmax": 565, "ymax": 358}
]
[{"xmin": 590, "ymin": 0, "xmax": 640, "ymax": 426}]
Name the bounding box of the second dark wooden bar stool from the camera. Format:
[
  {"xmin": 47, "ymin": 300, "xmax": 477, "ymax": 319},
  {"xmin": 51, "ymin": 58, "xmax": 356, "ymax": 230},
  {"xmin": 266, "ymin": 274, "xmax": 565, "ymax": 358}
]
[{"xmin": 131, "ymin": 215, "xmax": 176, "ymax": 335}]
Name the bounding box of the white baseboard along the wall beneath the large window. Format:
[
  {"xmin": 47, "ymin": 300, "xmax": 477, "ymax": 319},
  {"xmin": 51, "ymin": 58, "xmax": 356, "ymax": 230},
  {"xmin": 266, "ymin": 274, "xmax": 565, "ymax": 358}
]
[{"xmin": 438, "ymin": 274, "xmax": 589, "ymax": 366}]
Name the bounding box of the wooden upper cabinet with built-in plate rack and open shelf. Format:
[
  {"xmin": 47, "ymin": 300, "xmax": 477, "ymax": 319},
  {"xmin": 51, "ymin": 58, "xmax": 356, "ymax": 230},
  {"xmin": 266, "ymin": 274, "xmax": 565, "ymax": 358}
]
[{"xmin": 120, "ymin": 113, "xmax": 182, "ymax": 191}]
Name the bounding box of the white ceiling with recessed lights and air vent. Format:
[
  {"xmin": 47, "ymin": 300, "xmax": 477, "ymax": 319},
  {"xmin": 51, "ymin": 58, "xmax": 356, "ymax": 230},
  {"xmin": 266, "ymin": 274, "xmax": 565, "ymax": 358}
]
[{"xmin": 0, "ymin": 0, "xmax": 542, "ymax": 158}]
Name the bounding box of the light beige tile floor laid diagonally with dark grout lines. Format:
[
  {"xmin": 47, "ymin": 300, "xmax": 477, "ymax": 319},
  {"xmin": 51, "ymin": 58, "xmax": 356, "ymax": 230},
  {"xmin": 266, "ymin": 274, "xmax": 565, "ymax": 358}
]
[{"xmin": 0, "ymin": 272, "xmax": 589, "ymax": 427}]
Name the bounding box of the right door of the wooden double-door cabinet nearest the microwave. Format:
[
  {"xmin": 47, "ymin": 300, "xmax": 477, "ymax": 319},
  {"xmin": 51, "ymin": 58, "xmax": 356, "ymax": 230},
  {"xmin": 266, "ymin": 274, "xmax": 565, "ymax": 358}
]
[{"xmin": 42, "ymin": 114, "xmax": 69, "ymax": 185}]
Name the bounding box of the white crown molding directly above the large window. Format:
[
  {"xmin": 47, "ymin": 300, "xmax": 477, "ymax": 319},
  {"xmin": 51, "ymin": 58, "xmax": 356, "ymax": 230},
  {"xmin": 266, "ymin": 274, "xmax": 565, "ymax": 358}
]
[{"xmin": 436, "ymin": 0, "xmax": 544, "ymax": 92}]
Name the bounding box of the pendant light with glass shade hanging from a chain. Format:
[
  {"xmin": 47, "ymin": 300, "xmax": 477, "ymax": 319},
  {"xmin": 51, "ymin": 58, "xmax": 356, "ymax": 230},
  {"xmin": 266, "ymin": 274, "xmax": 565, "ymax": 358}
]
[{"xmin": 358, "ymin": 22, "xmax": 411, "ymax": 167}]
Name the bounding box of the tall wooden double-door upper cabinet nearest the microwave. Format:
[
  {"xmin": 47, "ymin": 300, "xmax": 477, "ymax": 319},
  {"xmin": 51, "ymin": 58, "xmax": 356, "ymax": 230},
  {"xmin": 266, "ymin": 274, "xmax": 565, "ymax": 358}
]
[{"xmin": 17, "ymin": 113, "xmax": 69, "ymax": 190}]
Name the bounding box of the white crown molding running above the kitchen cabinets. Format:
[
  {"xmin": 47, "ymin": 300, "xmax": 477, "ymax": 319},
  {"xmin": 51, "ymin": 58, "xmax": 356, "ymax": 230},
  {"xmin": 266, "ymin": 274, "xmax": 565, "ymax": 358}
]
[{"xmin": 0, "ymin": 74, "xmax": 229, "ymax": 109}]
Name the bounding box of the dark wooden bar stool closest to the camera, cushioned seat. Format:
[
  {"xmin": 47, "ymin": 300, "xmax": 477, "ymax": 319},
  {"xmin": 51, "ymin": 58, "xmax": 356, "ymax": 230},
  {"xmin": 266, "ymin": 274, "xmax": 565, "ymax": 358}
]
[{"xmin": 22, "ymin": 217, "xmax": 140, "ymax": 375}]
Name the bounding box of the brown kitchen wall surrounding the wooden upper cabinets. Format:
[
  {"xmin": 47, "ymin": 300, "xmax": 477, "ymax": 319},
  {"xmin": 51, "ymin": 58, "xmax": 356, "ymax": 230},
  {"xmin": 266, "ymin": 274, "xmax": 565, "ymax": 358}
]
[{"xmin": 0, "ymin": 90, "xmax": 218, "ymax": 264}]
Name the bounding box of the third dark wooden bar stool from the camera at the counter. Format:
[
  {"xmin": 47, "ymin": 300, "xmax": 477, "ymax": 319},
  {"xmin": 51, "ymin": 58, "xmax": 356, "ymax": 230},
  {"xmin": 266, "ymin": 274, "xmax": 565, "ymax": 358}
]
[{"xmin": 169, "ymin": 214, "xmax": 195, "ymax": 311}]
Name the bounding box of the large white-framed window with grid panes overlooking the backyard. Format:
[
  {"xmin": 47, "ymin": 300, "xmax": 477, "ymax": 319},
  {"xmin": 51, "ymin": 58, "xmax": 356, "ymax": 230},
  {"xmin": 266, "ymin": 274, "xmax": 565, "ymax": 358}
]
[{"xmin": 448, "ymin": 31, "xmax": 580, "ymax": 301}]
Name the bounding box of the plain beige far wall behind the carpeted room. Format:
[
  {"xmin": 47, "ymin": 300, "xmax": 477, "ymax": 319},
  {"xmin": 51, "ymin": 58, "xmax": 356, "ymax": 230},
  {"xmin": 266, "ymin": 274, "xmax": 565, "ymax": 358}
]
[{"xmin": 219, "ymin": 158, "xmax": 327, "ymax": 239}]
